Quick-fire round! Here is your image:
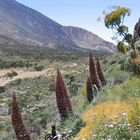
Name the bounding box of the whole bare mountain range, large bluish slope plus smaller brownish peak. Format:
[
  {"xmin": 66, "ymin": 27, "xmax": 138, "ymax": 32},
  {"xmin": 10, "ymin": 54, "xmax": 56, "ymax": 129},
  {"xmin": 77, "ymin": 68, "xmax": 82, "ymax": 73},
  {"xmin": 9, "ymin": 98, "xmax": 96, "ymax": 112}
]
[{"xmin": 0, "ymin": 0, "xmax": 115, "ymax": 52}]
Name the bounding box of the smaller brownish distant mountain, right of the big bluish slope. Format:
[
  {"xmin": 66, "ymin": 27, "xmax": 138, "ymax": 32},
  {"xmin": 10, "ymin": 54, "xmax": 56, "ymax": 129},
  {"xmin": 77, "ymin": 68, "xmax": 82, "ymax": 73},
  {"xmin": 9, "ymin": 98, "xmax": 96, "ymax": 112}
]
[{"xmin": 62, "ymin": 26, "xmax": 115, "ymax": 52}]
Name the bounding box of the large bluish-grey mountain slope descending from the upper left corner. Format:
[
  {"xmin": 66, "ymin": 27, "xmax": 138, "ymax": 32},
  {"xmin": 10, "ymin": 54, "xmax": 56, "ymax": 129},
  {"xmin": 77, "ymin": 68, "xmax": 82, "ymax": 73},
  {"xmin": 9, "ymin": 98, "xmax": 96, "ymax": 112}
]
[{"xmin": 0, "ymin": 0, "xmax": 77, "ymax": 49}]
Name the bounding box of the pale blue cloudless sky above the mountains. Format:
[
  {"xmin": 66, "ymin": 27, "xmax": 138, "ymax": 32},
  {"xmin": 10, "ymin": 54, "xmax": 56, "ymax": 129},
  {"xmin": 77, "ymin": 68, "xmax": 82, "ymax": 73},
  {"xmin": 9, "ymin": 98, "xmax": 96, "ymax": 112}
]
[{"xmin": 17, "ymin": 0, "xmax": 140, "ymax": 43}]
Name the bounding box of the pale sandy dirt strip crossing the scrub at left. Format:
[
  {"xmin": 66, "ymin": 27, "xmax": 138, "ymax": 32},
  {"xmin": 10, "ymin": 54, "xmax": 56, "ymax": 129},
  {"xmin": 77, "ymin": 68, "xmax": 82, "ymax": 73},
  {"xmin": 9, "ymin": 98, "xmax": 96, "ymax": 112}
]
[{"xmin": 0, "ymin": 68, "xmax": 55, "ymax": 86}]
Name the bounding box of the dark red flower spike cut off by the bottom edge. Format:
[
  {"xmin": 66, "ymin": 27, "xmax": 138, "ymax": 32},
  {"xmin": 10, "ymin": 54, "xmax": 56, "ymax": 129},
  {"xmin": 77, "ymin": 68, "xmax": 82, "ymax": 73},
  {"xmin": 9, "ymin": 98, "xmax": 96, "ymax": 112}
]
[{"xmin": 11, "ymin": 93, "xmax": 31, "ymax": 140}]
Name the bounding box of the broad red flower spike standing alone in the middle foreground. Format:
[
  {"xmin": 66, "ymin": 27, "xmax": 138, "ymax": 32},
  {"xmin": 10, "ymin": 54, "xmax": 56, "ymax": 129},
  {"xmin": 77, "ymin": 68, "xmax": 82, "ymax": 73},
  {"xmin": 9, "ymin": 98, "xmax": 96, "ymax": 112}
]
[{"xmin": 55, "ymin": 70, "xmax": 72, "ymax": 118}]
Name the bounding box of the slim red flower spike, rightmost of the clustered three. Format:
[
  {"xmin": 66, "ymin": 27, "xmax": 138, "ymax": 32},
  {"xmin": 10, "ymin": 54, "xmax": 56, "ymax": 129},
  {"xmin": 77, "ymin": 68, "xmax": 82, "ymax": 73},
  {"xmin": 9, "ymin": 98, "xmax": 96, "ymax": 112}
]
[{"xmin": 96, "ymin": 58, "xmax": 106, "ymax": 85}]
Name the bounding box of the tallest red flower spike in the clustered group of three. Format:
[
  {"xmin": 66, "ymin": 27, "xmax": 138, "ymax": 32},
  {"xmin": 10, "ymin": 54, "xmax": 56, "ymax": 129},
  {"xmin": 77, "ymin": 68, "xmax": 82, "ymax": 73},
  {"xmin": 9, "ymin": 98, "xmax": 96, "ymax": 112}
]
[{"xmin": 89, "ymin": 51, "xmax": 101, "ymax": 89}]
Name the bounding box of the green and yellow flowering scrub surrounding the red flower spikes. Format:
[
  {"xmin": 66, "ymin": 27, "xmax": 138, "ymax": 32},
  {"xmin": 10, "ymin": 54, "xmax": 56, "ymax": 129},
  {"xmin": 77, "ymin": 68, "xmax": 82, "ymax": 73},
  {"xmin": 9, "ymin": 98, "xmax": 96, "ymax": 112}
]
[{"xmin": 0, "ymin": 47, "xmax": 140, "ymax": 140}]
